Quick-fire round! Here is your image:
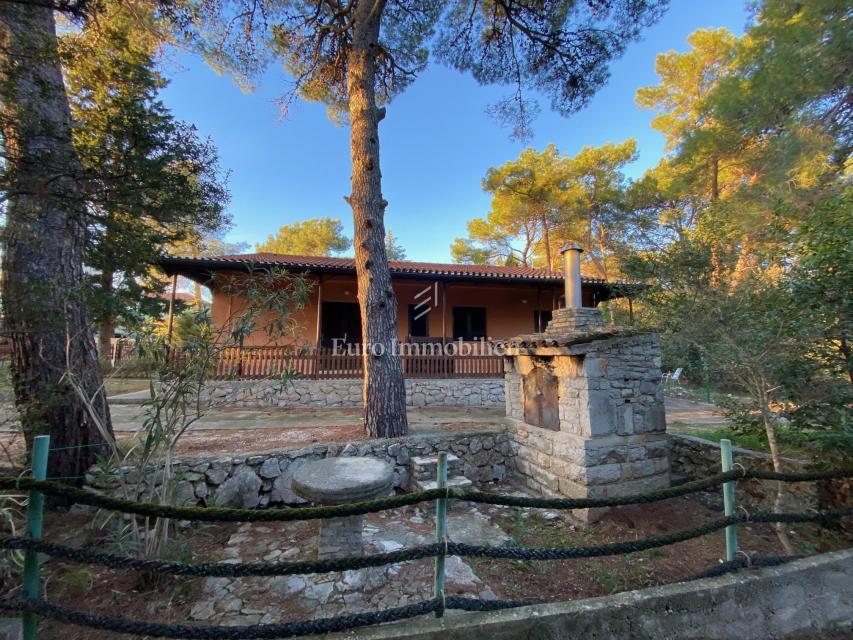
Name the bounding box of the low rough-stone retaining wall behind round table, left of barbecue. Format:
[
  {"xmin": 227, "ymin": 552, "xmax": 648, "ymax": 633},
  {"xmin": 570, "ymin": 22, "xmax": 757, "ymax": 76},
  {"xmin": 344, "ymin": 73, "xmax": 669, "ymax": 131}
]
[{"xmin": 87, "ymin": 430, "xmax": 515, "ymax": 508}]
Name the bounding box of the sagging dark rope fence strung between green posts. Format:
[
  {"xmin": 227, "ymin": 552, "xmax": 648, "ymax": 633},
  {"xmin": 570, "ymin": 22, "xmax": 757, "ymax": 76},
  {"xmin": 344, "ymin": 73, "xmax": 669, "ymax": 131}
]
[{"xmin": 0, "ymin": 436, "xmax": 853, "ymax": 640}]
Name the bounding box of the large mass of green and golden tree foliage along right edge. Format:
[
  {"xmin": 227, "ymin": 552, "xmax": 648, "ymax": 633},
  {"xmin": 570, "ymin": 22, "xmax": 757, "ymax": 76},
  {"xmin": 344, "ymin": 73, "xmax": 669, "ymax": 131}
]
[{"xmin": 623, "ymin": 0, "xmax": 853, "ymax": 476}]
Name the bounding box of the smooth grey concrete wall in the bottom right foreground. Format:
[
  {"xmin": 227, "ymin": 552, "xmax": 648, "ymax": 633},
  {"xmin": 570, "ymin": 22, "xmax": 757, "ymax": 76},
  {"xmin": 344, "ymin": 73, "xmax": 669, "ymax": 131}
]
[{"xmin": 336, "ymin": 550, "xmax": 853, "ymax": 640}]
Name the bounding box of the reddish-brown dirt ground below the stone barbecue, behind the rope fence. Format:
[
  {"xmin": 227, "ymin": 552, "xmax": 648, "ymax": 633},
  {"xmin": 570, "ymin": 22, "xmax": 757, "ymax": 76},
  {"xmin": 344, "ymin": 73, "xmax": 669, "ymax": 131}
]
[{"xmin": 472, "ymin": 496, "xmax": 853, "ymax": 602}]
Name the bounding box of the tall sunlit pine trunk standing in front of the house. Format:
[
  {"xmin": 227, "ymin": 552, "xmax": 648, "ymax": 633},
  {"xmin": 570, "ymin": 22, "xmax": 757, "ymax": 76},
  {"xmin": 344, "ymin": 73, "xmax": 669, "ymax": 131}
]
[{"xmin": 347, "ymin": 0, "xmax": 408, "ymax": 438}]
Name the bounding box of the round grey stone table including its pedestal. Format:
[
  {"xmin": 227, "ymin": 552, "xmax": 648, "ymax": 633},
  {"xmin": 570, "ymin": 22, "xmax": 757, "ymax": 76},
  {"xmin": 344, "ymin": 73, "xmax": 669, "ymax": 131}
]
[{"xmin": 293, "ymin": 458, "xmax": 394, "ymax": 560}]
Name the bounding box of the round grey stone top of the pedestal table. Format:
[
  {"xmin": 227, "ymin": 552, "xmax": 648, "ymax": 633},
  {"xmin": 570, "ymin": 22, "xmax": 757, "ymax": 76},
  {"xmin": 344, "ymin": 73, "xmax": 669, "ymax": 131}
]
[{"xmin": 293, "ymin": 458, "xmax": 394, "ymax": 504}]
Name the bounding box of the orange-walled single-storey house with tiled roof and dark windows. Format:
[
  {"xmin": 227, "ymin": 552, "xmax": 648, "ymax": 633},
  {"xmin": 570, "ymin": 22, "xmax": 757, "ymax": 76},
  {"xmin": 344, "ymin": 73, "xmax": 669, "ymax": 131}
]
[{"xmin": 159, "ymin": 253, "xmax": 627, "ymax": 347}]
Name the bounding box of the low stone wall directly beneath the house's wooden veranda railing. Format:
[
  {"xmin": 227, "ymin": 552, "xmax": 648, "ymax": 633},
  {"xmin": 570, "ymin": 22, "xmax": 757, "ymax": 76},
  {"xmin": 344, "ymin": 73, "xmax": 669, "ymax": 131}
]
[{"xmin": 202, "ymin": 378, "xmax": 504, "ymax": 407}]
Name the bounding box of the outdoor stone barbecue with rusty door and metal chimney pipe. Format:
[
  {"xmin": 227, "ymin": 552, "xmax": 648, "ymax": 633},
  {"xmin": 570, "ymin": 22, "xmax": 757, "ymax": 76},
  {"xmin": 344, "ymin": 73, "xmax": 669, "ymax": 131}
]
[{"xmin": 501, "ymin": 245, "xmax": 670, "ymax": 521}]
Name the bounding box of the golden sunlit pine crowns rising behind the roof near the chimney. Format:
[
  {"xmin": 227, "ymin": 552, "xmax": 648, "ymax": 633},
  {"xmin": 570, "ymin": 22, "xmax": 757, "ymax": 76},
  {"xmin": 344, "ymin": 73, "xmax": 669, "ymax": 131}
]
[{"xmin": 451, "ymin": 140, "xmax": 648, "ymax": 278}]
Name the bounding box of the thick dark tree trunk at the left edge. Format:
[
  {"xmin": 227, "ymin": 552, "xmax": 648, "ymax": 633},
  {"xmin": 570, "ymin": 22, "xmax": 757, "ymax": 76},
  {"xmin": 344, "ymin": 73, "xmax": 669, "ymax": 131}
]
[{"xmin": 0, "ymin": 2, "xmax": 112, "ymax": 482}]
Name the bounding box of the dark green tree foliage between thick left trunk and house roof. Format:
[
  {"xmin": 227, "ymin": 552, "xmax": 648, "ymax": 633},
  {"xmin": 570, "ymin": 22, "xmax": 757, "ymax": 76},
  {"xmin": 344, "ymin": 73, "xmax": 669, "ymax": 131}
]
[{"xmin": 62, "ymin": 2, "xmax": 228, "ymax": 354}]
